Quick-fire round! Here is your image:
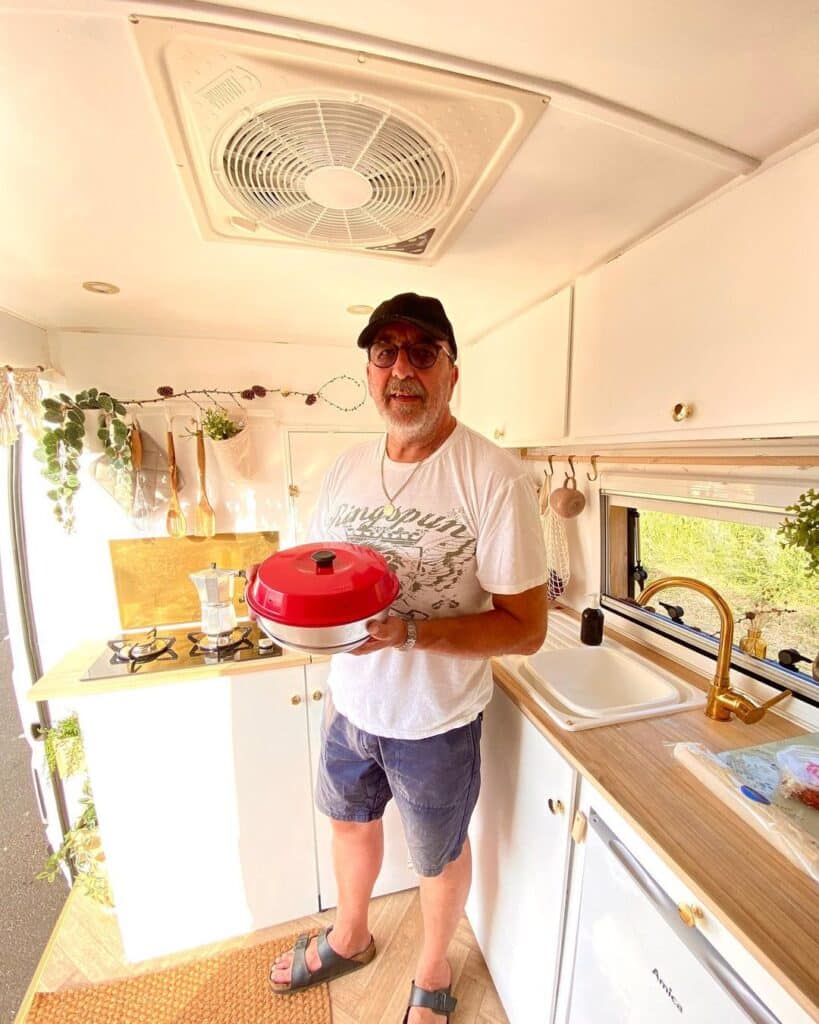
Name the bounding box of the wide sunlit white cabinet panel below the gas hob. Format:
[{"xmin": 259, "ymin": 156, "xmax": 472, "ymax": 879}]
[{"xmin": 78, "ymin": 667, "xmax": 318, "ymax": 961}]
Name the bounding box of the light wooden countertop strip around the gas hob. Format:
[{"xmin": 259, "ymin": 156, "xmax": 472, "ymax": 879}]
[{"xmin": 27, "ymin": 640, "xmax": 313, "ymax": 700}]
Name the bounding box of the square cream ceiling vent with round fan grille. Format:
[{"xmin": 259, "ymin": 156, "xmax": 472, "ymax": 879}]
[{"xmin": 134, "ymin": 17, "xmax": 546, "ymax": 262}]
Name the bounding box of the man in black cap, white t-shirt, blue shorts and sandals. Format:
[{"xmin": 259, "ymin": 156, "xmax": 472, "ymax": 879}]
[{"xmin": 270, "ymin": 293, "xmax": 547, "ymax": 1024}]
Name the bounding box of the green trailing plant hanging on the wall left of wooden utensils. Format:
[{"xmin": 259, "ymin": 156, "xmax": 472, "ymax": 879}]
[{"xmin": 34, "ymin": 388, "xmax": 131, "ymax": 534}]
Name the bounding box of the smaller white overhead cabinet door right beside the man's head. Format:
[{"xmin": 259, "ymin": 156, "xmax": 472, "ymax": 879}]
[{"xmin": 458, "ymin": 288, "xmax": 571, "ymax": 446}]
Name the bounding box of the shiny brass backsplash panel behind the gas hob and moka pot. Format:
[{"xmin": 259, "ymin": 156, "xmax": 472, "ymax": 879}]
[{"xmin": 109, "ymin": 531, "xmax": 278, "ymax": 630}]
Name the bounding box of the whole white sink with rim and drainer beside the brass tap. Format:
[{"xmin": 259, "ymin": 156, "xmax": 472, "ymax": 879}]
[{"xmin": 501, "ymin": 613, "xmax": 705, "ymax": 732}]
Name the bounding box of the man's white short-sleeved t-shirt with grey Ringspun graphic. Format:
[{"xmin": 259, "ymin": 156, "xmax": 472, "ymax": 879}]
[{"xmin": 310, "ymin": 423, "xmax": 547, "ymax": 739}]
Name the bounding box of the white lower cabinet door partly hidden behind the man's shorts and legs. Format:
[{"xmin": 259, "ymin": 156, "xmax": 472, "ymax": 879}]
[{"xmin": 307, "ymin": 662, "xmax": 418, "ymax": 910}]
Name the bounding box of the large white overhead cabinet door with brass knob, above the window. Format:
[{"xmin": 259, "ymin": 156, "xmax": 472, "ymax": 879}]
[{"xmin": 569, "ymin": 145, "xmax": 819, "ymax": 440}]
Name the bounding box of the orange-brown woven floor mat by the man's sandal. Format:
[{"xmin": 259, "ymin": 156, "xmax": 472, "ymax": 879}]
[{"xmin": 26, "ymin": 935, "xmax": 332, "ymax": 1024}]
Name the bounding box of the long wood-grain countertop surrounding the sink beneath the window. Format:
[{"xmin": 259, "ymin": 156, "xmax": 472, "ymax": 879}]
[{"xmin": 492, "ymin": 628, "xmax": 819, "ymax": 1021}]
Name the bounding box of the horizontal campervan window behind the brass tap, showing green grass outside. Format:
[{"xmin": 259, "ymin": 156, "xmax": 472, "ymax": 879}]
[{"xmin": 601, "ymin": 477, "xmax": 819, "ymax": 706}]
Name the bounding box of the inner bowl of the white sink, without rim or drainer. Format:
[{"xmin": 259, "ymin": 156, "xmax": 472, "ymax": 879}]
[{"xmin": 521, "ymin": 646, "xmax": 680, "ymax": 718}]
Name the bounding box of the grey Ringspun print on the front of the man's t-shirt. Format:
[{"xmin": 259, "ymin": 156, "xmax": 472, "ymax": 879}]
[{"xmin": 328, "ymin": 504, "xmax": 476, "ymax": 618}]
